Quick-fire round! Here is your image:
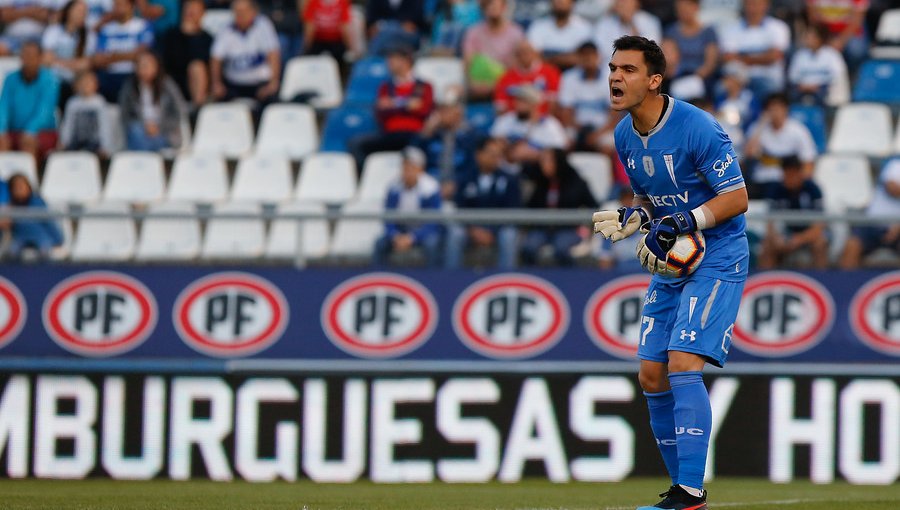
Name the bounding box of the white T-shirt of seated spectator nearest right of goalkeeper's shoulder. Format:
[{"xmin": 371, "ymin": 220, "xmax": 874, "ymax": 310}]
[{"xmin": 751, "ymin": 118, "xmax": 818, "ymax": 183}]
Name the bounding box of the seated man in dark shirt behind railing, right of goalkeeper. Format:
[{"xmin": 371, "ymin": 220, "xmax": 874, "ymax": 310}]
[{"xmin": 758, "ymin": 155, "xmax": 828, "ymax": 269}]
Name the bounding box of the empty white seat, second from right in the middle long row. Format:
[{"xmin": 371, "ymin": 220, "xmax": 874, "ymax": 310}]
[{"xmin": 296, "ymin": 152, "xmax": 357, "ymax": 204}]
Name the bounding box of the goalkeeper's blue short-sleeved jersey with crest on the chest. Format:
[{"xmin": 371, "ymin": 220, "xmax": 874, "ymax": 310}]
[{"xmin": 616, "ymin": 97, "xmax": 750, "ymax": 281}]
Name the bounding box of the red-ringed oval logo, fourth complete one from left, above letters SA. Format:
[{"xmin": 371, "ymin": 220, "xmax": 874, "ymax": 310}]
[{"xmin": 453, "ymin": 274, "xmax": 569, "ymax": 359}]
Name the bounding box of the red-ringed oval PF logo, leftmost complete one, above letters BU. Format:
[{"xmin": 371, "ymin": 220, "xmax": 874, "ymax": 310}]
[{"xmin": 43, "ymin": 271, "xmax": 156, "ymax": 356}]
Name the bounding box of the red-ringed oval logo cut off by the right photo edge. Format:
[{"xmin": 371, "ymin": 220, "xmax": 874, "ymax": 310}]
[{"xmin": 850, "ymin": 271, "xmax": 900, "ymax": 356}]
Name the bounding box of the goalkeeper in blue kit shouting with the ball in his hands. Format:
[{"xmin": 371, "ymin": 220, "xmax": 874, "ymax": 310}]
[{"xmin": 593, "ymin": 36, "xmax": 749, "ymax": 510}]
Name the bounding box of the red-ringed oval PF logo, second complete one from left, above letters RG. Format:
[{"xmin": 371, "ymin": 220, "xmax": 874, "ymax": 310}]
[{"xmin": 172, "ymin": 272, "xmax": 289, "ymax": 357}]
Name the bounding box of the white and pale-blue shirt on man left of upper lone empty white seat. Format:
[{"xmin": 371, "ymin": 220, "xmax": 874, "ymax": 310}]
[{"xmin": 212, "ymin": 15, "xmax": 279, "ymax": 85}]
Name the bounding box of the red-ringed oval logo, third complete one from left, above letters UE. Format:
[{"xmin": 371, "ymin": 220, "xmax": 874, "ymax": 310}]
[{"xmin": 321, "ymin": 273, "xmax": 438, "ymax": 358}]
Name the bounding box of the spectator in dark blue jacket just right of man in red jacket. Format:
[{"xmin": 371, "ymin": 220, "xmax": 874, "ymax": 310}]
[{"xmin": 415, "ymin": 89, "xmax": 476, "ymax": 200}]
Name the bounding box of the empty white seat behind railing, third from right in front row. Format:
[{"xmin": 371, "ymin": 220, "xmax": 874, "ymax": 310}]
[{"xmin": 202, "ymin": 202, "xmax": 266, "ymax": 260}]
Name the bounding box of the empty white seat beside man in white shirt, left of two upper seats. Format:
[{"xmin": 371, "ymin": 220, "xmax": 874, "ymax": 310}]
[{"xmin": 279, "ymin": 55, "xmax": 344, "ymax": 108}]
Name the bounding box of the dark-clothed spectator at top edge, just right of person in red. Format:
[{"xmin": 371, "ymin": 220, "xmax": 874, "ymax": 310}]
[{"xmin": 366, "ymin": 0, "xmax": 428, "ymax": 55}]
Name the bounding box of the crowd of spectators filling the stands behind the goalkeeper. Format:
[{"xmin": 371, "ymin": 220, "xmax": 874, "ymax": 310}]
[{"xmin": 0, "ymin": 0, "xmax": 900, "ymax": 268}]
